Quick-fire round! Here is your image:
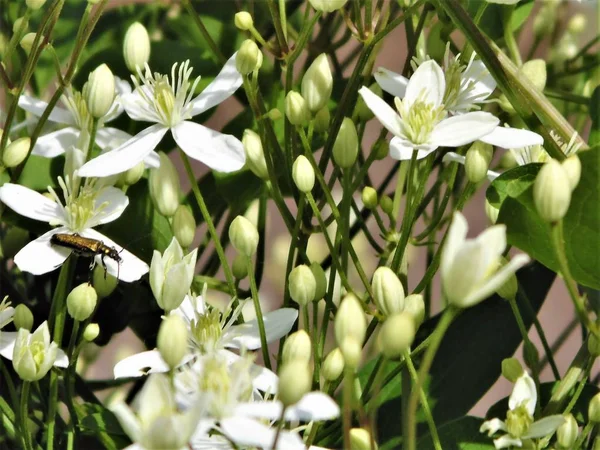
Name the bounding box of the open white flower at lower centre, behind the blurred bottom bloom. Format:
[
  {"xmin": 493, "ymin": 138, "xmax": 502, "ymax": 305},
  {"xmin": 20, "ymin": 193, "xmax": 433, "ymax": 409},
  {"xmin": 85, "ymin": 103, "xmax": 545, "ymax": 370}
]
[{"xmin": 114, "ymin": 295, "xmax": 298, "ymax": 378}]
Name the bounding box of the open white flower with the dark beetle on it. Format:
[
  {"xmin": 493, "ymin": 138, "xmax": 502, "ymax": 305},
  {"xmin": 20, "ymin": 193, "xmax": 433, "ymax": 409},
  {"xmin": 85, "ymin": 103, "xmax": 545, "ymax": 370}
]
[{"xmin": 0, "ymin": 177, "xmax": 148, "ymax": 282}]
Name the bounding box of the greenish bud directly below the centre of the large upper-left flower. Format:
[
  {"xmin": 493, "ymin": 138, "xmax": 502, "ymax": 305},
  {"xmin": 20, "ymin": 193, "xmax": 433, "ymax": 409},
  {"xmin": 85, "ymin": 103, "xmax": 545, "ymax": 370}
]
[{"xmin": 148, "ymin": 152, "xmax": 181, "ymax": 217}]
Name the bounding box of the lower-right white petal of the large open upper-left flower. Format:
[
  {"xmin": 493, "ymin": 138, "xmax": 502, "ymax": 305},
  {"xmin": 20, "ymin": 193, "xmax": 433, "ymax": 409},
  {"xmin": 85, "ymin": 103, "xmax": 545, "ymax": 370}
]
[{"xmin": 172, "ymin": 121, "xmax": 246, "ymax": 172}]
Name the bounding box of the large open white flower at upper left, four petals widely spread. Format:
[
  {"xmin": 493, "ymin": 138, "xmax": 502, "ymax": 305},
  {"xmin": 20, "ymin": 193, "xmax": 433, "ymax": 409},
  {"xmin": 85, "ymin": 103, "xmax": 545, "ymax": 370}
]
[{"xmin": 80, "ymin": 54, "xmax": 245, "ymax": 177}]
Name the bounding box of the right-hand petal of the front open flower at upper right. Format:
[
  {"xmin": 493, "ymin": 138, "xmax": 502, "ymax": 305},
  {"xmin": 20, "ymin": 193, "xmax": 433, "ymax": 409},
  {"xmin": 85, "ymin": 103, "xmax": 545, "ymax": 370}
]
[{"xmin": 429, "ymin": 111, "xmax": 499, "ymax": 147}]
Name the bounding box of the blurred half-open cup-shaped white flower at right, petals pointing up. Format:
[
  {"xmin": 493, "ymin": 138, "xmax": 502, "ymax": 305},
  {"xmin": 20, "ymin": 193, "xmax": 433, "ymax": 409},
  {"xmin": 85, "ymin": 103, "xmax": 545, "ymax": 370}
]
[{"xmin": 440, "ymin": 211, "xmax": 529, "ymax": 308}]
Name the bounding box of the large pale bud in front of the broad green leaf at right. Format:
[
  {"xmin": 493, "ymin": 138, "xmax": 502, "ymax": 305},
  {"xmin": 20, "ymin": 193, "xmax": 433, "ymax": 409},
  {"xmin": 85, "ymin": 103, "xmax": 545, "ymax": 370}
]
[{"xmin": 533, "ymin": 159, "xmax": 571, "ymax": 223}]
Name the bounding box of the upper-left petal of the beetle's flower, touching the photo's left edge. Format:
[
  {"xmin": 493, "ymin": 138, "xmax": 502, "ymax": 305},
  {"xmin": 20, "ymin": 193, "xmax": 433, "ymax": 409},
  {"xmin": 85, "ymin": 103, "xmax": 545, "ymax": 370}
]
[{"xmin": 0, "ymin": 183, "xmax": 63, "ymax": 223}]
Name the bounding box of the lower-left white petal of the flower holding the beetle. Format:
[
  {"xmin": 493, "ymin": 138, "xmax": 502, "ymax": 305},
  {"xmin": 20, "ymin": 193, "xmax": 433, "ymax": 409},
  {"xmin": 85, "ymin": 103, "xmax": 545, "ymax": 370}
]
[{"xmin": 14, "ymin": 227, "xmax": 71, "ymax": 275}]
